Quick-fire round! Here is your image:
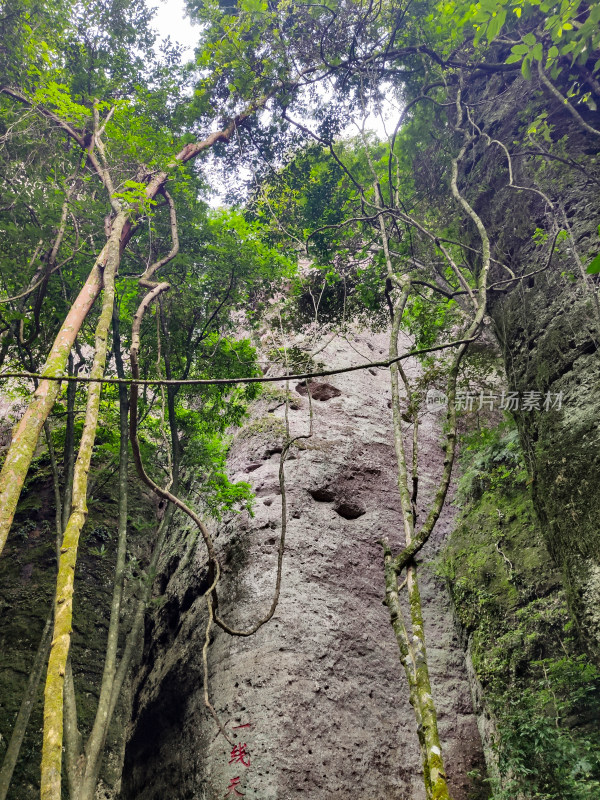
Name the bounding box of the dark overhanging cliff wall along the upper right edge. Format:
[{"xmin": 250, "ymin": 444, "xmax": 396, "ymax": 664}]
[{"xmin": 460, "ymin": 65, "xmax": 600, "ymax": 662}]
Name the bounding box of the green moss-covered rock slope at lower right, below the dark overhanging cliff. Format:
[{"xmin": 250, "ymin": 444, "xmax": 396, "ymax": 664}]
[{"xmin": 437, "ymin": 450, "xmax": 600, "ymax": 800}]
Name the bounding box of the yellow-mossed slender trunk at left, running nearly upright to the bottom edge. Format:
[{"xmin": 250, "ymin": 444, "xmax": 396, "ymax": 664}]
[{"xmin": 39, "ymin": 214, "xmax": 126, "ymax": 800}]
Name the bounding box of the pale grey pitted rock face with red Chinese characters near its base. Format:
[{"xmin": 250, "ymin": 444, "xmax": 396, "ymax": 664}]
[{"xmin": 122, "ymin": 335, "xmax": 488, "ymax": 800}]
